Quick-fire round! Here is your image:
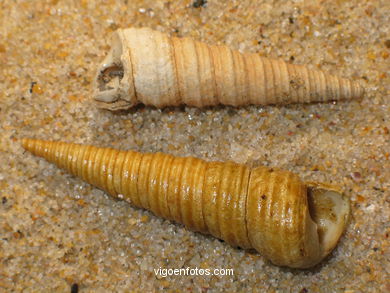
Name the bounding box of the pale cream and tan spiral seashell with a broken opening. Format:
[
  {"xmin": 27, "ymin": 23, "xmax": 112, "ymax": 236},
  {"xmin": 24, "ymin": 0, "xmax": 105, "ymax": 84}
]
[{"xmin": 94, "ymin": 28, "xmax": 364, "ymax": 110}]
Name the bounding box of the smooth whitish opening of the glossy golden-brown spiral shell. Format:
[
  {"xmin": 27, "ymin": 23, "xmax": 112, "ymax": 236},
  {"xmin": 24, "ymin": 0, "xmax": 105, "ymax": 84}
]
[{"xmin": 307, "ymin": 186, "xmax": 349, "ymax": 256}]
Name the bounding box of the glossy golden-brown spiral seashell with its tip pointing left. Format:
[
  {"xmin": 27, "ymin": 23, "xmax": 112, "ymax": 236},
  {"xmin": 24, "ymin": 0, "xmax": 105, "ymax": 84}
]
[{"xmin": 23, "ymin": 139, "xmax": 349, "ymax": 268}]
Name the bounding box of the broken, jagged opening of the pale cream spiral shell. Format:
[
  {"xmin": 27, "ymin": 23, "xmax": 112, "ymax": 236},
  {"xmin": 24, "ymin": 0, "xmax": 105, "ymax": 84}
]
[{"xmin": 95, "ymin": 34, "xmax": 124, "ymax": 103}]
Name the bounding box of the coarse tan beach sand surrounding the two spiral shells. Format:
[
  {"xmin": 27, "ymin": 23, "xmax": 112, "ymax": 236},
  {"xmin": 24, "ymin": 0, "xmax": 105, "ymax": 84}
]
[{"xmin": 0, "ymin": 0, "xmax": 390, "ymax": 292}]
